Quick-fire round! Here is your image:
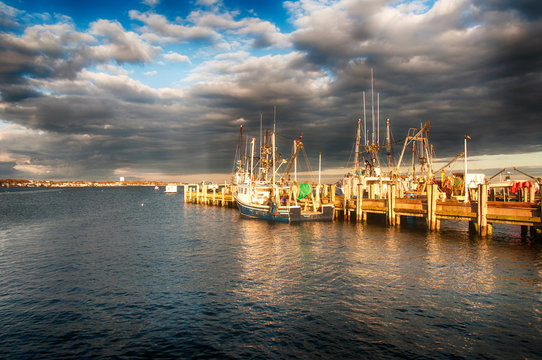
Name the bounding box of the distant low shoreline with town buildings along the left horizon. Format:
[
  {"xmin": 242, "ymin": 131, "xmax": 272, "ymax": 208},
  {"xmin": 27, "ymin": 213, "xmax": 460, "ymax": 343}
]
[{"xmin": 0, "ymin": 179, "xmax": 175, "ymax": 188}]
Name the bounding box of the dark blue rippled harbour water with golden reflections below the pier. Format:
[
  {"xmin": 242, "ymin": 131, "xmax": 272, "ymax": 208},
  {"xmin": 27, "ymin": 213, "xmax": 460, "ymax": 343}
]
[{"xmin": 0, "ymin": 187, "xmax": 542, "ymax": 359}]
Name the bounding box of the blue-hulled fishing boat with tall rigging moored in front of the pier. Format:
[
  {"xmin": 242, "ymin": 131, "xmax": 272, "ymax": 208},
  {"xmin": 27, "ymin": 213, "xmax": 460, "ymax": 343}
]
[{"xmin": 233, "ymin": 119, "xmax": 334, "ymax": 223}]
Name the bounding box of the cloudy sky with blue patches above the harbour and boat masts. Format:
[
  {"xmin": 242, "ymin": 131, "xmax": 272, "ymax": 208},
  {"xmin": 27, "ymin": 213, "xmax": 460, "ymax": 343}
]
[{"xmin": 0, "ymin": 0, "xmax": 542, "ymax": 182}]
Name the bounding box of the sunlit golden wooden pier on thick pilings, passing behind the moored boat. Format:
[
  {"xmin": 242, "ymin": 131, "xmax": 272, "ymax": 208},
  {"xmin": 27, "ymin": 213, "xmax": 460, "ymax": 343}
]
[{"xmin": 183, "ymin": 183, "xmax": 542, "ymax": 238}]
